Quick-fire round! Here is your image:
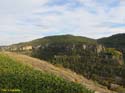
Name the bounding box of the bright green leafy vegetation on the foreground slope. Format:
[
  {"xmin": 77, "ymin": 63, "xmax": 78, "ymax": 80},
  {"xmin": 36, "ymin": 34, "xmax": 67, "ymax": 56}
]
[{"xmin": 0, "ymin": 53, "xmax": 92, "ymax": 93}]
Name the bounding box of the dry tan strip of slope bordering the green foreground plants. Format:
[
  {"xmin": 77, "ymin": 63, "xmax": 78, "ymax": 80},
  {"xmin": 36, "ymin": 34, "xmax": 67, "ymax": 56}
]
[{"xmin": 6, "ymin": 53, "xmax": 113, "ymax": 93}]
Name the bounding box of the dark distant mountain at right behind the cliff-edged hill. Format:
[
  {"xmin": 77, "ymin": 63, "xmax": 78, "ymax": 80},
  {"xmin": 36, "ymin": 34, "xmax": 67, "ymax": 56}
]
[{"xmin": 97, "ymin": 34, "xmax": 125, "ymax": 48}]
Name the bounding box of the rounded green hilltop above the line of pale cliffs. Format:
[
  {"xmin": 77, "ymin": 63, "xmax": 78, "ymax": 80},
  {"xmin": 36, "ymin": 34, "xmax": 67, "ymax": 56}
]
[{"xmin": 13, "ymin": 35, "xmax": 96, "ymax": 46}]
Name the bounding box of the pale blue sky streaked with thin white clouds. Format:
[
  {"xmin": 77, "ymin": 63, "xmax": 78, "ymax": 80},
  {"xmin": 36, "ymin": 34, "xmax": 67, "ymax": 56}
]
[{"xmin": 0, "ymin": 0, "xmax": 125, "ymax": 45}]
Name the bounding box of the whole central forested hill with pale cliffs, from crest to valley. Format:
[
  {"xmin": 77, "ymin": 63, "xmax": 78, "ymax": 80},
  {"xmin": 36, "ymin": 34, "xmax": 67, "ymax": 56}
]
[{"xmin": 0, "ymin": 34, "xmax": 125, "ymax": 93}]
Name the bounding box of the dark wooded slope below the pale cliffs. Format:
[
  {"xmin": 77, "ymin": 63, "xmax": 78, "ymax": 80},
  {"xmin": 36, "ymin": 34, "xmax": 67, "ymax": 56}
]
[{"xmin": 33, "ymin": 43, "xmax": 125, "ymax": 92}]
